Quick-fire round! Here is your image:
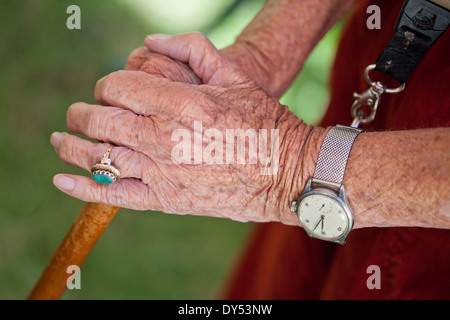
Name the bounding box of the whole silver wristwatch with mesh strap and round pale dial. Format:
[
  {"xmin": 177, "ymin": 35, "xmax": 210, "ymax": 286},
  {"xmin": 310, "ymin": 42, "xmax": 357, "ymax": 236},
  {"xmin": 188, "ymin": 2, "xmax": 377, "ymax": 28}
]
[{"xmin": 291, "ymin": 125, "xmax": 363, "ymax": 244}]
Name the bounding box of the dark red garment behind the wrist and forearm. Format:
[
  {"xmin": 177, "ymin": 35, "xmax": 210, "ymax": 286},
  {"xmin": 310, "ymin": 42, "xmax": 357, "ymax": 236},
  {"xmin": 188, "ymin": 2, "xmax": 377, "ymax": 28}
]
[{"xmin": 225, "ymin": 0, "xmax": 450, "ymax": 299}]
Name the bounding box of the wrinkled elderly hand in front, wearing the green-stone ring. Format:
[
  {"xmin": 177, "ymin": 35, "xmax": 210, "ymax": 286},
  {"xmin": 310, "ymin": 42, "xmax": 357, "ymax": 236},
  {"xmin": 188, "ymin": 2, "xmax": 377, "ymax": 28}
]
[{"xmin": 51, "ymin": 33, "xmax": 323, "ymax": 225}]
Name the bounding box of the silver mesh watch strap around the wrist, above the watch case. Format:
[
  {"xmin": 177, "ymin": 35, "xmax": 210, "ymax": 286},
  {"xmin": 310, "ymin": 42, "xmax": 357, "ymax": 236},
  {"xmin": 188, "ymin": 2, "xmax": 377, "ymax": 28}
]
[{"xmin": 312, "ymin": 125, "xmax": 363, "ymax": 189}]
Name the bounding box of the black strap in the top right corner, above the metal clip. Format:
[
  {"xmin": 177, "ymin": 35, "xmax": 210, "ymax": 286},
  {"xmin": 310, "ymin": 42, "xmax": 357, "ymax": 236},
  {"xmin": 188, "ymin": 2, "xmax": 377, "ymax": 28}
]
[{"xmin": 375, "ymin": 0, "xmax": 450, "ymax": 83}]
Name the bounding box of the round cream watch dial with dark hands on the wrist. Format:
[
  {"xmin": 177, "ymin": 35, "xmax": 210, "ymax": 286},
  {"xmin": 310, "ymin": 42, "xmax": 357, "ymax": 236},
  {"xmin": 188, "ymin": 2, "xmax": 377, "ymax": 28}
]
[{"xmin": 298, "ymin": 194, "xmax": 350, "ymax": 240}]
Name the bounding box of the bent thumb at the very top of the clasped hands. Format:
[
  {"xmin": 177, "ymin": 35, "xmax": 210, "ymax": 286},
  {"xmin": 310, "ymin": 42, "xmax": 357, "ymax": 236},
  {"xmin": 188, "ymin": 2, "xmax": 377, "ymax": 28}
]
[{"xmin": 145, "ymin": 32, "xmax": 241, "ymax": 85}]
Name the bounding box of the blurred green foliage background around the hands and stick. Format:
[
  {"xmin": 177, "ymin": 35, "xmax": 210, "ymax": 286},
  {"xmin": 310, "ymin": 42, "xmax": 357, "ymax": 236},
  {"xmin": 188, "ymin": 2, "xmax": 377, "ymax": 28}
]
[{"xmin": 0, "ymin": 0, "xmax": 339, "ymax": 299}]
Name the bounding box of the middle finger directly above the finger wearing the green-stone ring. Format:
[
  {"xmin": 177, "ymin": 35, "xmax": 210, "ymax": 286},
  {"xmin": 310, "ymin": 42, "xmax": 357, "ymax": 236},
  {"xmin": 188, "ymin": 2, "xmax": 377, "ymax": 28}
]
[{"xmin": 67, "ymin": 102, "xmax": 157, "ymax": 152}]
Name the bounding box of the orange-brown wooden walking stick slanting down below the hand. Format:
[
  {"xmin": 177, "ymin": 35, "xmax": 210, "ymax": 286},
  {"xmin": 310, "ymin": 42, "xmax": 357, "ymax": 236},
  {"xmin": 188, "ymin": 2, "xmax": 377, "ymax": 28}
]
[{"xmin": 28, "ymin": 203, "xmax": 119, "ymax": 300}]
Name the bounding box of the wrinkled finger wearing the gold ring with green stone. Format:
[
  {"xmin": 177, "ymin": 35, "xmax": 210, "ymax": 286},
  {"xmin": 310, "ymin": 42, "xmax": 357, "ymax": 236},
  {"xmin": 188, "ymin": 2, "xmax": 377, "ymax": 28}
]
[{"xmin": 50, "ymin": 132, "xmax": 147, "ymax": 179}]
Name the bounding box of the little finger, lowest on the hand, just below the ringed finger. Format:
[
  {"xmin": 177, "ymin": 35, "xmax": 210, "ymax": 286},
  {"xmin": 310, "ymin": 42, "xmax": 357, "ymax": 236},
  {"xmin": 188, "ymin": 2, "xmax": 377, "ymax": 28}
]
[{"xmin": 53, "ymin": 174, "xmax": 162, "ymax": 211}]
